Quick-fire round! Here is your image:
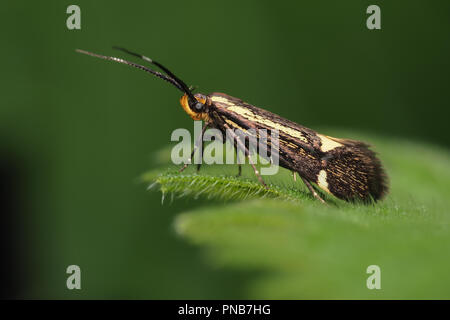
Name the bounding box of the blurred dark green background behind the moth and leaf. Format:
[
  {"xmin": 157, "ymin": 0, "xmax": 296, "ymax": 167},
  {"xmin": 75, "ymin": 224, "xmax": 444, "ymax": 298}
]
[{"xmin": 0, "ymin": 0, "xmax": 450, "ymax": 299}]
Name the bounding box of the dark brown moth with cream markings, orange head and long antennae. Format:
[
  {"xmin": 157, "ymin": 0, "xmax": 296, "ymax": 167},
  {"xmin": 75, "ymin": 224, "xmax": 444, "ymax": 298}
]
[{"xmin": 76, "ymin": 47, "xmax": 388, "ymax": 203}]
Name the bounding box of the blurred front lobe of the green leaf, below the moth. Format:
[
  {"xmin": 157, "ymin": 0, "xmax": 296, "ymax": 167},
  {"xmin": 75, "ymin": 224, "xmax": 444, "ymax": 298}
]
[{"xmin": 175, "ymin": 200, "xmax": 450, "ymax": 299}]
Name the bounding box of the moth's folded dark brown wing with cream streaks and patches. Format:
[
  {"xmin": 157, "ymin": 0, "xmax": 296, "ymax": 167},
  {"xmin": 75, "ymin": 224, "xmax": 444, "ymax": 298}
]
[{"xmin": 208, "ymin": 93, "xmax": 388, "ymax": 200}]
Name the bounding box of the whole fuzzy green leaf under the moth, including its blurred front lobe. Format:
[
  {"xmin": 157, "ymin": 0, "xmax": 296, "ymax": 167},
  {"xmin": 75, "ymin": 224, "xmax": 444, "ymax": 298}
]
[{"xmin": 143, "ymin": 133, "xmax": 450, "ymax": 299}]
